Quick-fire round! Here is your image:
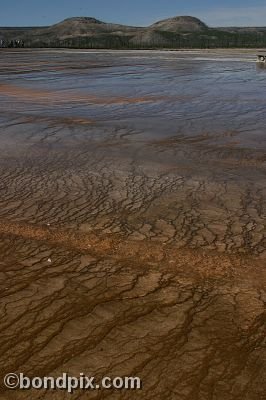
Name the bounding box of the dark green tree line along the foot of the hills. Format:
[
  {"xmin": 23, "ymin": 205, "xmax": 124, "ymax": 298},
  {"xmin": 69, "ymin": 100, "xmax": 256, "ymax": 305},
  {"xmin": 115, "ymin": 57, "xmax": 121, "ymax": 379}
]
[{"xmin": 3, "ymin": 29, "xmax": 266, "ymax": 49}]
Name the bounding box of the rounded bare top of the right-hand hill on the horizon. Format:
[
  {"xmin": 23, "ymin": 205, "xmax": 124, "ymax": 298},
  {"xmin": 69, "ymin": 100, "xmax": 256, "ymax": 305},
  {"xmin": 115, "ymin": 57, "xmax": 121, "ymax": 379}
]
[{"xmin": 150, "ymin": 16, "xmax": 208, "ymax": 32}]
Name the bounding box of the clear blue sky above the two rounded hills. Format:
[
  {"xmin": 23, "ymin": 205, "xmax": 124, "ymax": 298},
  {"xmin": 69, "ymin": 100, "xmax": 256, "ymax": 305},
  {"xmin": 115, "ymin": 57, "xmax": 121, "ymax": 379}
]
[{"xmin": 0, "ymin": 0, "xmax": 266, "ymax": 26}]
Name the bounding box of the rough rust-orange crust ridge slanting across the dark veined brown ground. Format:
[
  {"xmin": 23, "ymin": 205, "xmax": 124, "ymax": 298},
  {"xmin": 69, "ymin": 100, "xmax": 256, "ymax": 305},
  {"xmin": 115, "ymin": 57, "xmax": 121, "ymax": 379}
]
[{"xmin": 0, "ymin": 220, "xmax": 264, "ymax": 281}]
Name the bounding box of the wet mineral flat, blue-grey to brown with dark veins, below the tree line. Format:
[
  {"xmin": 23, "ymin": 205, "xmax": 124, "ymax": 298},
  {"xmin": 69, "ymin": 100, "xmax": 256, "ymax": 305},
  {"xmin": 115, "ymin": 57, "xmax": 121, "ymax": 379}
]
[{"xmin": 0, "ymin": 50, "xmax": 266, "ymax": 400}]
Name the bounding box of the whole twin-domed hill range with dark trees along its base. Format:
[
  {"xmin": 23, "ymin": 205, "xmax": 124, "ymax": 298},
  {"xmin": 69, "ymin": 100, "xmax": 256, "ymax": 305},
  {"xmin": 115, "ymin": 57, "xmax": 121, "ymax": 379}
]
[{"xmin": 0, "ymin": 16, "xmax": 266, "ymax": 49}]
